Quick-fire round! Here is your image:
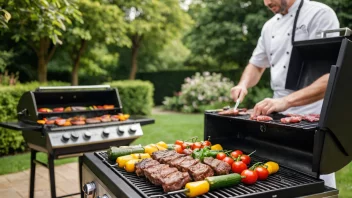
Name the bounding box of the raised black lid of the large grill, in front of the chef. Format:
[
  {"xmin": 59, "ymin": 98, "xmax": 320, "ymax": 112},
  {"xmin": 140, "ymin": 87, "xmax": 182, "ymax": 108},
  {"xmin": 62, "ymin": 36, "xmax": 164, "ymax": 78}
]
[{"xmin": 286, "ymin": 32, "xmax": 352, "ymax": 174}]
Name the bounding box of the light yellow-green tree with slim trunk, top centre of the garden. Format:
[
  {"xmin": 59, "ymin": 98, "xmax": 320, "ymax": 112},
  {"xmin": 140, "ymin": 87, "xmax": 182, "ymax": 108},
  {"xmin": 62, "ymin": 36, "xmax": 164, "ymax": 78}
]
[{"xmin": 115, "ymin": 0, "xmax": 192, "ymax": 79}]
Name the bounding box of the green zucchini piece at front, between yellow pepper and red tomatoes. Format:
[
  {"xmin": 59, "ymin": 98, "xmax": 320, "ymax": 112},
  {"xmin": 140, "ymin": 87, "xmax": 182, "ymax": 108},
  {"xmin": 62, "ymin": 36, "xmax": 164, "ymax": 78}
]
[{"xmin": 205, "ymin": 173, "xmax": 242, "ymax": 190}]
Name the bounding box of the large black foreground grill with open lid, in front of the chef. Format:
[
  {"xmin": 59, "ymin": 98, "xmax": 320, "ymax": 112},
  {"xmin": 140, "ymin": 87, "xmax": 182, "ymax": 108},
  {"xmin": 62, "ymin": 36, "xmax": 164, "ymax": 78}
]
[{"xmin": 82, "ymin": 28, "xmax": 352, "ymax": 198}]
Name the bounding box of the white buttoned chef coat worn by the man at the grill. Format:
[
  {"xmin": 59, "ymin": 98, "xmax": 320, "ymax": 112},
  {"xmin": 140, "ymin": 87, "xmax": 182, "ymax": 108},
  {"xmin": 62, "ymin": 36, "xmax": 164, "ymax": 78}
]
[{"xmin": 249, "ymin": 0, "xmax": 340, "ymax": 188}]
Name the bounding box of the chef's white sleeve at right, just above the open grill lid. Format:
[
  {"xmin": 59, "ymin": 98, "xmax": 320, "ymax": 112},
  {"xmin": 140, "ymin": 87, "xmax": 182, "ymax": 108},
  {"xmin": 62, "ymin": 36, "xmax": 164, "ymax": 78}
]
[{"xmin": 308, "ymin": 8, "xmax": 340, "ymax": 39}]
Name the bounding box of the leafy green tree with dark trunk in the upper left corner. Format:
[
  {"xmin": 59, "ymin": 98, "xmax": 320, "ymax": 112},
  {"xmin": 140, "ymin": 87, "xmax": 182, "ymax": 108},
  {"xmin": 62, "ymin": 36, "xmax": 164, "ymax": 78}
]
[{"xmin": 0, "ymin": 0, "xmax": 81, "ymax": 82}]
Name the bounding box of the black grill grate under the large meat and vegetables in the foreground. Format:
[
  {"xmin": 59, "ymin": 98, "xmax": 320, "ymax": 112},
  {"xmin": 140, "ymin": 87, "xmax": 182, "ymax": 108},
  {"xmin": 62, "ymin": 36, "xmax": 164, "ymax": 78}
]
[{"xmin": 95, "ymin": 152, "xmax": 324, "ymax": 198}]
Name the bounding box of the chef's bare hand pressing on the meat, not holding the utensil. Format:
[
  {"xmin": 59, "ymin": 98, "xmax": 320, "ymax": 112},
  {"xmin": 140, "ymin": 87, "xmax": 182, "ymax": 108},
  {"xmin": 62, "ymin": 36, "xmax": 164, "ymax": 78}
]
[{"xmin": 251, "ymin": 97, "xmax": 290, "ymax": 116}]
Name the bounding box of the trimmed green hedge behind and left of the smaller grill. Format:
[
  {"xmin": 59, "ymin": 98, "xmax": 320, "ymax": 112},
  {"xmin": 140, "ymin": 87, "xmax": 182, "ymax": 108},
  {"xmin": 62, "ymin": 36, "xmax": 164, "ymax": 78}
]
[{"xmin": 0, "ymin": 81, "xmax": 68, "ymax": 156}]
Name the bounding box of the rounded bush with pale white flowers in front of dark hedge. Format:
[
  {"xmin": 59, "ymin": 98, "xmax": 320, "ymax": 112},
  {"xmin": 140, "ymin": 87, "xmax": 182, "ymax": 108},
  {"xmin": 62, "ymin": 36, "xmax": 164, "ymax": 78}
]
[{"xmin": 163, "ymin": 72, "xmax": 234, "ymax": 113}]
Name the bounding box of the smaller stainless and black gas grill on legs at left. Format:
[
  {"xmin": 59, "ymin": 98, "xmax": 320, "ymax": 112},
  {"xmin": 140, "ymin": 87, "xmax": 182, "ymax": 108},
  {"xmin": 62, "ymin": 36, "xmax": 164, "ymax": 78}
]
[{"xmin": 0, "ymin": 85, "xmax": 154, "ymax": 197}]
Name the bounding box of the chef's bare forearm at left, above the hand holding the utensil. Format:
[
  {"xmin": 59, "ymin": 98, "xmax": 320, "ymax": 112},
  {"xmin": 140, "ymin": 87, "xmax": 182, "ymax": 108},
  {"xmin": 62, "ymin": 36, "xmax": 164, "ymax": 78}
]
[{"xmin": 238, "ymin": 63, "xmax": 265, "ymax": 89}]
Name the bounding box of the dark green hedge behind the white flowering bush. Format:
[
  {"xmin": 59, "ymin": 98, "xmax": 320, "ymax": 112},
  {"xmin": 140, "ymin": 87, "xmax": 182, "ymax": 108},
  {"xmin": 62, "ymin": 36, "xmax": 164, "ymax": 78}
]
[{"xmin": 137, "ymin": 69, "xmax": 270, "ymax": 105}]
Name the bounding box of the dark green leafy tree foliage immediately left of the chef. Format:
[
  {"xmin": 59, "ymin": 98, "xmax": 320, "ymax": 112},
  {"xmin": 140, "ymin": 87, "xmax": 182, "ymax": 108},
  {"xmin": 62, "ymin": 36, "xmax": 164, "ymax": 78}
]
[{"xmin": 184, "ymin": 0, "xmax": 272, "ymax": 69}]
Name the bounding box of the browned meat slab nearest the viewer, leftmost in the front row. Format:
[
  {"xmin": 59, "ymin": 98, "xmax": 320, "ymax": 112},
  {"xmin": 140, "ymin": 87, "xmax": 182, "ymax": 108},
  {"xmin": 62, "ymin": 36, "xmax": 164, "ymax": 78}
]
[{"xmin": 136, "ymin": 158, "xmax": 191, "ymax": 192}]
